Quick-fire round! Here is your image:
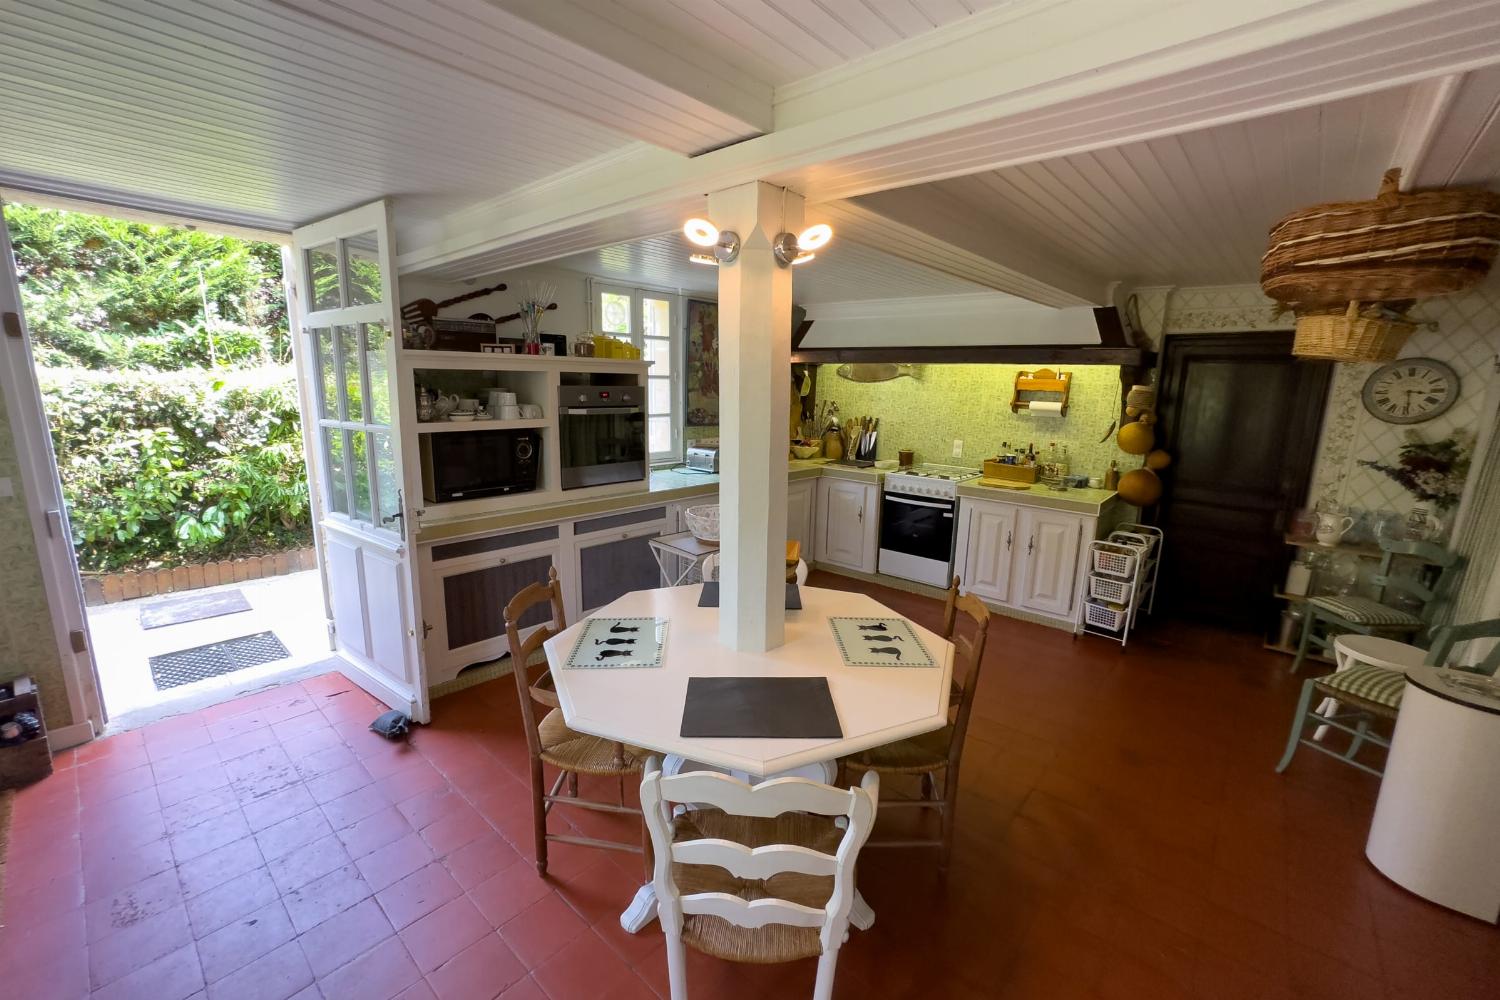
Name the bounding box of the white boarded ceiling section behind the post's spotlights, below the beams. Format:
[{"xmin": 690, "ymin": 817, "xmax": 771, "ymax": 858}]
[{"xmin": 554, "ymin": 232, "xmax": 989, "ymax": 304}]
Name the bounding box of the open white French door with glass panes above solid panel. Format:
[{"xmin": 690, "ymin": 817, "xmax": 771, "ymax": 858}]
[{"xmin": 291, "ymin": 201, "xmax": 429, "ymax": 723}]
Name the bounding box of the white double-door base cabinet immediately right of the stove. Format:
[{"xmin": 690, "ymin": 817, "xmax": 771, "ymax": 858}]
[{"xmin": 954, "ymin": 496, "xmax": 1100, "ymax": 622}]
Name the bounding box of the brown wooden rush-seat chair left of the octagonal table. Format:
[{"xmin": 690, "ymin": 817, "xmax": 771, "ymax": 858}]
[{"xmin": 506, "ymin": 567, "xmax": 651, "ymax": 876}]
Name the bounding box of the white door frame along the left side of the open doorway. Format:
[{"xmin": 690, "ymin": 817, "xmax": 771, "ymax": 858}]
[{"xmin": 0, "ymin": 202, "xmax": 108, "ymax": 750}]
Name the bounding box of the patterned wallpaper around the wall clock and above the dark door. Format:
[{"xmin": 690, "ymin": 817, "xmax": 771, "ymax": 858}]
[{"xmin": 1136, "ymin": 280, "xmax": 1500, "ymax": 514}]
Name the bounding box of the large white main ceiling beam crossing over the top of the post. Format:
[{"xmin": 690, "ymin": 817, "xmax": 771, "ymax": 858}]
[{"xmin": 401, "ymin": 0, "xmax": 1500, "ymax": 270}]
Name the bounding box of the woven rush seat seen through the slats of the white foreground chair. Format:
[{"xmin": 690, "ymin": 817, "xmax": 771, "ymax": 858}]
[{"xmin": 672, "ymin": 808, "xmax": 843, "ymax": 964}]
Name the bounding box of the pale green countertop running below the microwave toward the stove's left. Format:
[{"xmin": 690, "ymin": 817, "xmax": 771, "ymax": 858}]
[{"xmin": 417, "ymin": 459, "xmax": 885, "ymax": 544}]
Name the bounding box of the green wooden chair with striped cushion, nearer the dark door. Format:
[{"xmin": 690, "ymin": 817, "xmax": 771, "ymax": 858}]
[{"xmin": 1292, "ymin": 540, "xmax": 1460, "ymax": 673}]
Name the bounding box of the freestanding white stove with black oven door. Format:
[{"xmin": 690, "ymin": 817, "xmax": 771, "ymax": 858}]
[{"xmin": 878, "ymin": 465, "xmax": 980, "ymax": 588}]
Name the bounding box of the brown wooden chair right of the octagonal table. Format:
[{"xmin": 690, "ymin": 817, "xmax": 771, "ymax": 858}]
[{"xmin": 840, "ymin": 577, "xmax": 990, "ymax": 871}]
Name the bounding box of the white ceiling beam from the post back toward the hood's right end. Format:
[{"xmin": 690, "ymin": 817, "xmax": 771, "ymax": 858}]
[{"xmin": 807, "ymin": 187, "xmax": 1107, "ymax": 307}]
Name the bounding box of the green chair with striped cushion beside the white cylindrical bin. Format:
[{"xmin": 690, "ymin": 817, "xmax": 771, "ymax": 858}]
[{"xmin": 1277, "ymin": 618, "xmax": 1500, "ymax": 777}]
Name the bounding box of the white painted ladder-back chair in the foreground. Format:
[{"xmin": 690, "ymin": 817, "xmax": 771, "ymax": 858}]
[{"xmin": 641, "ymin": 757, "xmax": 881, "ymax": 1000}]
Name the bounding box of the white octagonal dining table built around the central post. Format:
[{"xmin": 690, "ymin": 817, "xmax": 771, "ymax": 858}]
[{"xmin": 545, "ymin": 583, "xmax": 953, "ymax": 931}]
